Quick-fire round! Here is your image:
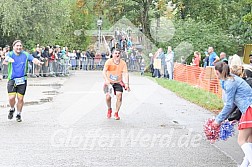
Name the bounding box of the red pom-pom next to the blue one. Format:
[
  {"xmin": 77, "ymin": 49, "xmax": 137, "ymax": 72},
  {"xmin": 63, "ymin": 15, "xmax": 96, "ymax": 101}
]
[{"xmin": 204, "ymin": 119, "xmax": 220, "ymax": 143}]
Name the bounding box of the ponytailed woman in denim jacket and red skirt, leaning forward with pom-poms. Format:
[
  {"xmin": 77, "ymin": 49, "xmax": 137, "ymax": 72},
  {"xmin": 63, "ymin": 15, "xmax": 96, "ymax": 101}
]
[{"xmin": 213, "ymin": 62, "xmax": 252, "ymax": 166}]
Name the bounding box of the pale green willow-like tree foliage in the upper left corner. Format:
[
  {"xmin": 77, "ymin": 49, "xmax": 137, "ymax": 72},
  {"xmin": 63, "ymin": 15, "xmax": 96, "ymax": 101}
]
[{"xmin": 0, "ymin": 0, "xmax": 71, "ymax": 48}]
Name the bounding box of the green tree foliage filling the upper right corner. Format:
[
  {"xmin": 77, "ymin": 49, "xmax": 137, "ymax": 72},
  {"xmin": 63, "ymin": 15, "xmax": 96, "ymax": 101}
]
[{"xmin": 171, "ymin": 0, "xmax": 252, "ymax": 46}]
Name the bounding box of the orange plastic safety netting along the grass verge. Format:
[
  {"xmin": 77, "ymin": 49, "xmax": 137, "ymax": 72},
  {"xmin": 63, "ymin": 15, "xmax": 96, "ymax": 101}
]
[{"xmin": 174, "ymin": 63, "xmax": 222, "ymax": 97}]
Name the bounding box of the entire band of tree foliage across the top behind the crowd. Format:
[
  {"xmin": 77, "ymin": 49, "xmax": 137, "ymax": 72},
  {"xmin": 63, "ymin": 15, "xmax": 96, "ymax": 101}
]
[{"xmin": 0, "ymin": 0, "xmax": 252, "ymax": 52}]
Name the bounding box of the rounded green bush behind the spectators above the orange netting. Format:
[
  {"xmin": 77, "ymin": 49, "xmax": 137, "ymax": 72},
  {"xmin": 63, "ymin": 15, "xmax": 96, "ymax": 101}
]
[{"xmin": 161, "ymin": 19, "xmax": 238, "ymax": 62}]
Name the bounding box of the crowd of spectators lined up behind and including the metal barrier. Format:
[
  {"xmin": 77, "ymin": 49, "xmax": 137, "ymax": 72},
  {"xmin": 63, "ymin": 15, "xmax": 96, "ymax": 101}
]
[{"xmin": 0, "ymin": 40, "xmax": 145, "ymax": 79}]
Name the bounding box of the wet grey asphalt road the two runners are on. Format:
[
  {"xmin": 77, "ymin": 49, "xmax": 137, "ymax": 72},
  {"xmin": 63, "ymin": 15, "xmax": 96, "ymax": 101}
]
[{"xmin": 0, "ymin": 71, "xmax": 243, "ymax": 167}]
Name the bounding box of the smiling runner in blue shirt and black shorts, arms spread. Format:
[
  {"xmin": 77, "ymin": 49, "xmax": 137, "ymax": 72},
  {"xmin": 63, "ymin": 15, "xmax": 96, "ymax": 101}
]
[{"xmin": 4, "ymin": 40, "xmax": 43, "ymax": 122}]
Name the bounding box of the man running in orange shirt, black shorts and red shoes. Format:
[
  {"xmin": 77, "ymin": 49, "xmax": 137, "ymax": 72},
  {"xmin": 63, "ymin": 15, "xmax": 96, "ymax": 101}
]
[{"xmin": 103, "ymin": 49, "xmax": 130, "ymax": 120}]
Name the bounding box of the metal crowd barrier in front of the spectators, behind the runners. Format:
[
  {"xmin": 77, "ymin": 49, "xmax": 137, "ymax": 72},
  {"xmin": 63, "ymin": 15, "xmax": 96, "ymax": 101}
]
[{"xmin": 0, "ymin": 57, "xmax": 144, "ymax": 78}]
